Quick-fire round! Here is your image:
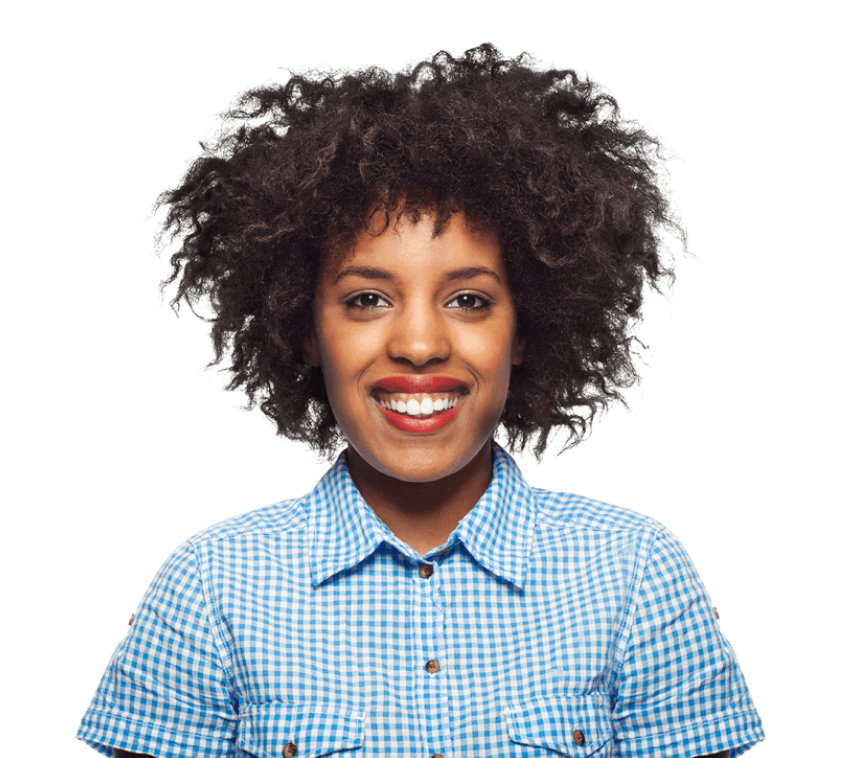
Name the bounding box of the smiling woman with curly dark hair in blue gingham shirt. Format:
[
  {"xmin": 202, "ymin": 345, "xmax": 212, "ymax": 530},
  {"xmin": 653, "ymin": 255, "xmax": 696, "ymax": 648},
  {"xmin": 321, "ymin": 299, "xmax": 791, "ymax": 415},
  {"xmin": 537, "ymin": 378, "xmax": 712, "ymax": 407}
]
[{"xmin": 75, "ymin": 44, "xmax": 765, "ymax": 758}]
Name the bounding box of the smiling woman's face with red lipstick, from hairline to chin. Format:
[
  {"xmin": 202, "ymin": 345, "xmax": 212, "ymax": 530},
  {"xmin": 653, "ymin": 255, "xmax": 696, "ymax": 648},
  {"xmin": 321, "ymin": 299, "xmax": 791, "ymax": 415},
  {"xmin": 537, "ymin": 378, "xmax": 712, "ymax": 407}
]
[{"xmin": 304, "ymin": 205, "xmax": 525, "ymax": 482}]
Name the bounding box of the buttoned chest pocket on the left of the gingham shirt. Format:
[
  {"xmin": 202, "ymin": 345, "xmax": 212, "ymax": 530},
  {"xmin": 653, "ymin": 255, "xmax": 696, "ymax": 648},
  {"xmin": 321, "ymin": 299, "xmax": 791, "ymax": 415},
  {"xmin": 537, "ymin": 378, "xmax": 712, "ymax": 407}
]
[{"xmin": 239, "ymin": 703, "xmax": 364, "ymax": 758}]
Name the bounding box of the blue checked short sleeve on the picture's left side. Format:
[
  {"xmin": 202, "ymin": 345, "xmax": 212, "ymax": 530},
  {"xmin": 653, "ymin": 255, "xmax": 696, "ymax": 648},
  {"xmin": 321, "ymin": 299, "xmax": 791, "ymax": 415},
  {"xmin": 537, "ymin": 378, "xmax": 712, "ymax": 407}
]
[{"xmin": 74, "ymin": 543, "xmax": 239, "ymax": 758}]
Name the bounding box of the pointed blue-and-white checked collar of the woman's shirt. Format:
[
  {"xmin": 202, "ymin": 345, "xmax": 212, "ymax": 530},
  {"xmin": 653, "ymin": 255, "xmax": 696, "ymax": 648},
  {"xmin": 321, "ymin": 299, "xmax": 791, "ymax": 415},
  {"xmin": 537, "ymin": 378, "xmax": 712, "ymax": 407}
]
[{"xmin": 305, "ymin": 441, "xmax": 537, "ymax": 588}]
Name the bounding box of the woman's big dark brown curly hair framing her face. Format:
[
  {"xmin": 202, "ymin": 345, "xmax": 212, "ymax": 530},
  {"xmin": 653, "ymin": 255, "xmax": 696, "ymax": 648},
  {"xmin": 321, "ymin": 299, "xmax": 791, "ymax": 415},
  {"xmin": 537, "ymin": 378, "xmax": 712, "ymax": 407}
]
[{"xmin": 145, "ymin": 43, "xmax": 702, "ymax": 466}]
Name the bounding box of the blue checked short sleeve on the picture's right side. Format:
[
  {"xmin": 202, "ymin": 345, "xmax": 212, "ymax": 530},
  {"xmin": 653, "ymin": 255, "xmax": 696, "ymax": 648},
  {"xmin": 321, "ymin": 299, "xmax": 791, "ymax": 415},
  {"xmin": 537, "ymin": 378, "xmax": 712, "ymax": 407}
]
[{"xmin": 612, "ymin": 527, "xmax": 766, "ymax": 758}]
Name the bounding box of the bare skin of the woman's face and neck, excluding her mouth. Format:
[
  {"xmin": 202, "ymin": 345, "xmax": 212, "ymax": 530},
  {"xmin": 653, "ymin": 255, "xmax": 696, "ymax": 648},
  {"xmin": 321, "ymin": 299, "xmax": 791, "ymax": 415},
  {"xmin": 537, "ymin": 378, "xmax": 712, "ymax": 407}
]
[{"xmin": 304, "ymin": 208, "xmax": 525, "ymax": 553}]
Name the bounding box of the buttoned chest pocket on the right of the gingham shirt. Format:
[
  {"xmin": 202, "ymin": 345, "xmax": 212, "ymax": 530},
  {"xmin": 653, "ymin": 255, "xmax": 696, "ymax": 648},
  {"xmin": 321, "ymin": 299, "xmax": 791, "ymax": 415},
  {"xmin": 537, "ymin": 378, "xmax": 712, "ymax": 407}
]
[{"xmin": 502, "ymin": 695, "xmax": 614, "ymax": 758}]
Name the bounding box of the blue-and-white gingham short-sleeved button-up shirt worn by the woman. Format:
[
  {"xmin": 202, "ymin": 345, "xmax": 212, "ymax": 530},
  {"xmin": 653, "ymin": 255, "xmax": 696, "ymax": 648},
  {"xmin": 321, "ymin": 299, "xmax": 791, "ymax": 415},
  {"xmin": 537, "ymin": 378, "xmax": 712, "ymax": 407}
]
[{"xmin": 75, "ymin": 443, "xmax": 765, "ymax": 758}]
